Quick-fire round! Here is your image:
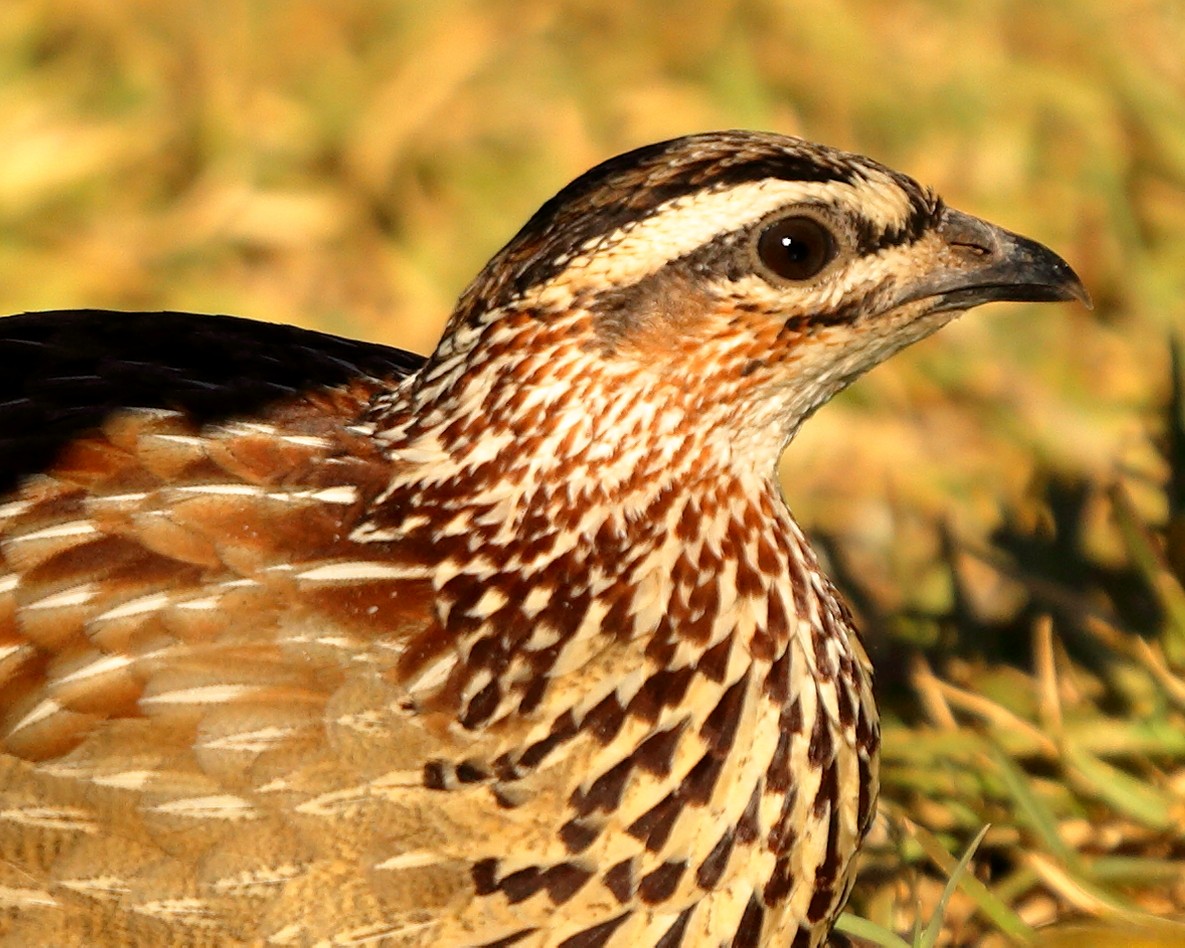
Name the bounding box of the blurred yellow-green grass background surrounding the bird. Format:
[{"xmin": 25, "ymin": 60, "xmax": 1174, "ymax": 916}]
[{"xmin": 0, "ymin": 0, "xmax": 1185, "ymax": 944}]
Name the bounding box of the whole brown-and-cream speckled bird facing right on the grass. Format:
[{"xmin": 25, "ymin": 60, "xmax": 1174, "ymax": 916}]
[{"xmin": 0, "ymin": 130, "xmax": 1089, "ymax": 948}]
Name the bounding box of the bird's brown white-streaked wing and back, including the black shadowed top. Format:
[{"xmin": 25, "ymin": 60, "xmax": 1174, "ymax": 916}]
[{"xmin": 0, "ymin": 312, "xmax": 478, "ymax": 944}]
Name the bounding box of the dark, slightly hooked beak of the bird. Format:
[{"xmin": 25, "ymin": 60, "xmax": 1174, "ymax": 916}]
[{"xmin": 897, "ymin": 207, "xmax": 1091, "ymax": 313}]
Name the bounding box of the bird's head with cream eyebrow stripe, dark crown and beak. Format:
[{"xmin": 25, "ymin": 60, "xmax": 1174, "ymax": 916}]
[{"xmin": 428, "ymin": 132, "xmax": 1088, "ymax": 471}]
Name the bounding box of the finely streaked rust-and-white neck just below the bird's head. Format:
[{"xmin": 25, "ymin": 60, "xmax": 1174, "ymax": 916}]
[{"xmin": 372, "ymin": 310, "xmax": 793, "ymax": 518}]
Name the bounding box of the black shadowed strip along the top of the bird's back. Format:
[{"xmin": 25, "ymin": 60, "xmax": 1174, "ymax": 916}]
[{"xmin": 0, "ymin": 309, "xmax": 423, "ymax": 493}]
